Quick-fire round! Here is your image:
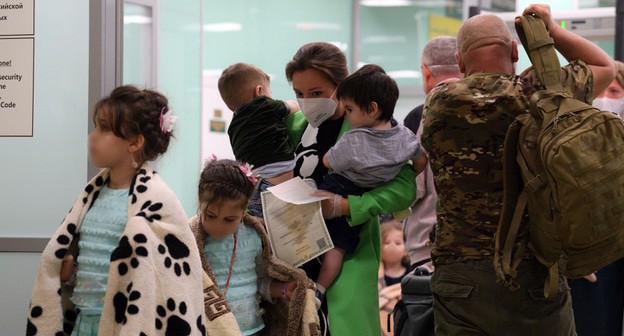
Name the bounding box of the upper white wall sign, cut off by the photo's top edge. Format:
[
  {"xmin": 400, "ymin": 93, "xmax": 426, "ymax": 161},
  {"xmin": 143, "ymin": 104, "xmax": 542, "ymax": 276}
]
[{"xmin": 0, "ymin": 0, "xmax": 35, "ymax": 36}]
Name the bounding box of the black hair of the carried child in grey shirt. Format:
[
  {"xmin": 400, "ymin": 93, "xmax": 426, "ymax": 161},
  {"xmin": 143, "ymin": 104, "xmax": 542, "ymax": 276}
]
[{"xmin": 336, "ymin": 64, "xmax": 399, "ymax": 121}]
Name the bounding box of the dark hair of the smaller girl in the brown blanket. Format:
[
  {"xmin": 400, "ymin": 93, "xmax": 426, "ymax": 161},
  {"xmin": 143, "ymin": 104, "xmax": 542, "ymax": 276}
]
[{"xmin": 198, "ymin": 159, "xmax": 254, "ymax": 206}]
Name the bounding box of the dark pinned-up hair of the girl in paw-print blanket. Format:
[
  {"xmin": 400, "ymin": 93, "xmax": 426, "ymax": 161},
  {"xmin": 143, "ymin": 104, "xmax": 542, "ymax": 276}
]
[{"xmin": 93, "ymin": 85, "xmax": 173, "ymax": 161}]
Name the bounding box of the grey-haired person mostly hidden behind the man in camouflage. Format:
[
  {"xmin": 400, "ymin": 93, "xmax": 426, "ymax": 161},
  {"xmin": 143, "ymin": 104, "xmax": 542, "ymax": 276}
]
[{"xmin": 403, "ymin": 36, "xmax": 464, "ymax": 271}]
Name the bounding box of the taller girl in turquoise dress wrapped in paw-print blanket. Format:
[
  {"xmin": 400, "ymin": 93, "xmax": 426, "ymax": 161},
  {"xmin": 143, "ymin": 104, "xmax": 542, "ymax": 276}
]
[{"xmin": 26, "ymin": 86, "xmax": 205, "ymax": 336}]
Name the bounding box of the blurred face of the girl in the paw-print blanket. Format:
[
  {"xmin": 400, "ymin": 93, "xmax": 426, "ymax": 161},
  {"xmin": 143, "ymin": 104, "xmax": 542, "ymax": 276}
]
[{"xmin": 89, "ymin": 114, "xmax": 138, "ymax": 168}]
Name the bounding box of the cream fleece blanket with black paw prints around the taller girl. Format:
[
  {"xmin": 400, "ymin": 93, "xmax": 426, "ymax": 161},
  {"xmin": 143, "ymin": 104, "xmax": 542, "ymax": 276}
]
[{"xmin": 26, "ymin": 165, "xmax": 205, "ymax": 336}]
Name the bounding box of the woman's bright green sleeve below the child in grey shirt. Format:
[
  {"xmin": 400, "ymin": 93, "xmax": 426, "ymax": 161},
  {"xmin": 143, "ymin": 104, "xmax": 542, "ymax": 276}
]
[{"xmin": 347, "ymin": 164, "xmax": 416, "ymax": 225}]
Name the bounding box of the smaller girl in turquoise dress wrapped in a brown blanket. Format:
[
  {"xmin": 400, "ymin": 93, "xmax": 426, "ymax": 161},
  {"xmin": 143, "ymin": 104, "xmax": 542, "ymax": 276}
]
[{"xmin": 191, "ymin": 159, "xmax": 319, "ymax": 336}]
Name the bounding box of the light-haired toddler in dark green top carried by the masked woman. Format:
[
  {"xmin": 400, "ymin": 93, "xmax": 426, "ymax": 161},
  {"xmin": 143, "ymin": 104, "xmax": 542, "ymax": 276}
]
[{"xmin": 218, "ymin": 63, "xmax": 299, "ymax": 217}]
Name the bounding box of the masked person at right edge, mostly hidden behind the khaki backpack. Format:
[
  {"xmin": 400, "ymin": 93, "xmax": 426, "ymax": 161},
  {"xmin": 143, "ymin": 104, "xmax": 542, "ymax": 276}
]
[{"xmin": 570, "ymin": 61, "xmax": 624, "ymax": 336}]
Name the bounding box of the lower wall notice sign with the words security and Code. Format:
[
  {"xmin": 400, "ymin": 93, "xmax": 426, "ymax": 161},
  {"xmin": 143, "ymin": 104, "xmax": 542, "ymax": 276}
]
[{"xmin": 0, "ymin": 37, "xmax": 35, "ymax": 136}]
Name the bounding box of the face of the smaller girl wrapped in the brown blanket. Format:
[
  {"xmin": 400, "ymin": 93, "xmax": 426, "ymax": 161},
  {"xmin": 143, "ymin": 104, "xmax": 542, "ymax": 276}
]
[{"xmin": 200, "ymin": 200, "xmax": 246, "ymax": 239}]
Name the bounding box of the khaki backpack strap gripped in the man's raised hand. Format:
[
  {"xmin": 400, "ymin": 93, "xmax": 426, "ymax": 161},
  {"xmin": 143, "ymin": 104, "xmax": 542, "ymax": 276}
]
[{"xmin": 516, "ymin": 15, "xmax": 563, "ymax": 92}]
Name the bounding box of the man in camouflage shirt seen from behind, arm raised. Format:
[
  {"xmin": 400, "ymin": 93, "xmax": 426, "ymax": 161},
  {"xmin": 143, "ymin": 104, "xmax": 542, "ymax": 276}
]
[{"xmin": 422, "ymin": 5, "xmax": 615, "ymax": 336}]
